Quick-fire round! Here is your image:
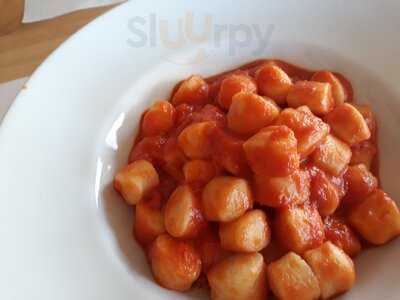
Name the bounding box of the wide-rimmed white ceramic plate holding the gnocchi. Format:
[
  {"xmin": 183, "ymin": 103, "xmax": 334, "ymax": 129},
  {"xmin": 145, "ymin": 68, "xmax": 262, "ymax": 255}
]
[{"xmin": 0, "ymin": 0, "xmax": 400, "ymax": 300}]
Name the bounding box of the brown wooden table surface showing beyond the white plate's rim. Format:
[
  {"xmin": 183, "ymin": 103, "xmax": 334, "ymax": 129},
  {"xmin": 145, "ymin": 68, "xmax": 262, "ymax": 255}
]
[{"xmin": 0, "ymin": 0, "xmax": 115, "ymax": 83}]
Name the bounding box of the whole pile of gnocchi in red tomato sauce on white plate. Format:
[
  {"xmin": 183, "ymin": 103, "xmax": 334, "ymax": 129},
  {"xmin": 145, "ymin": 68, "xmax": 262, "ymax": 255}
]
[{"xmin": 114, "ymin": 60, "xmax": 400, "ymax": 300}]
